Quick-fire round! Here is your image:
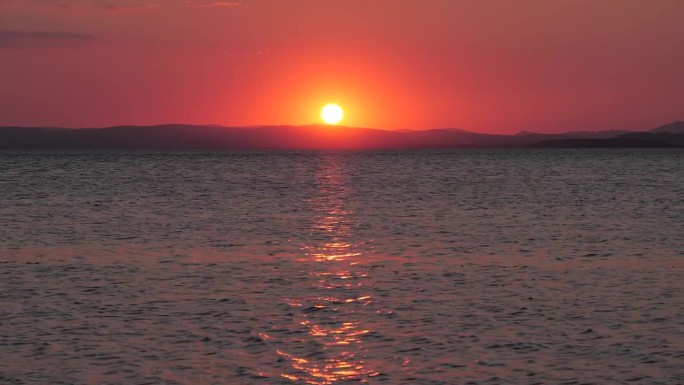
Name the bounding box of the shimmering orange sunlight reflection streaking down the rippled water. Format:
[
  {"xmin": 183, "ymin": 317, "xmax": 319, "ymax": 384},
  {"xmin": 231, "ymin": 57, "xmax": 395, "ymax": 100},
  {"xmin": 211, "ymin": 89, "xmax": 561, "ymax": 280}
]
[{"xmin": 277, "ymin": 157, "xmax": 380, "ymax": 385}]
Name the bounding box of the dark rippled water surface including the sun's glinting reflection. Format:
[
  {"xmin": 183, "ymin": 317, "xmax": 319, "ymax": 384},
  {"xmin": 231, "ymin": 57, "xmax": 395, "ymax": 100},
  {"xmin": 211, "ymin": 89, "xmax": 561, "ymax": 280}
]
[{"xmin": 0, "ymin": 150, "xmax": 684, "ymax": 385}]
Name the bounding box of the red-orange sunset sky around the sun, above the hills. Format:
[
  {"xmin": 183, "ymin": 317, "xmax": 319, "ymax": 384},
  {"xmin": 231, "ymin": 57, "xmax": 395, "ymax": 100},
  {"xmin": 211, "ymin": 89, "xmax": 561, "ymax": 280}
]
[{"xmin": 0, "ymin": 0, "xmax": 684, "ymax": 133}]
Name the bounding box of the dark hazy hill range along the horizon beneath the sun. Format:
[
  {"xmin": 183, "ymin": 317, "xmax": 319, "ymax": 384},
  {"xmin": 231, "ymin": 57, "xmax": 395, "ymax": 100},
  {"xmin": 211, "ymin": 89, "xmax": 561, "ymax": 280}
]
[{"xmin": 0, "ymin": 122, "xmax": 684, "ymax": 150}]
